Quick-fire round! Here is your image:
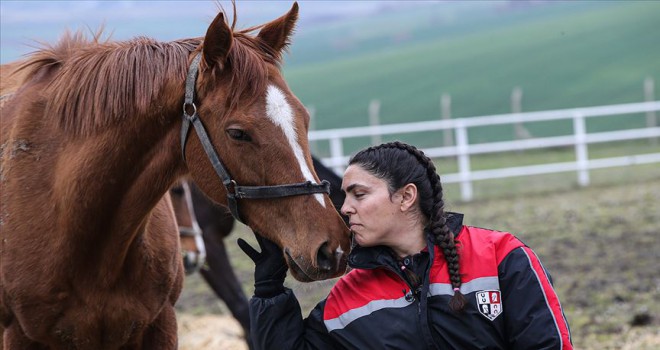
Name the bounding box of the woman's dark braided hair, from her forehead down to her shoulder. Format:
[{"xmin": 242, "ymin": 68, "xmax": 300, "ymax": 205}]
[{"xmin": 351, "ymin": 141, "xmax": 466, "ymax": 312}]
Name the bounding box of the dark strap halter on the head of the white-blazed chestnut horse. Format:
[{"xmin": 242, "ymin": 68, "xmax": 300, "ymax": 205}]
[{"xmin": 181, "ymin": 53, "xmax": 330, "ymax": 223}]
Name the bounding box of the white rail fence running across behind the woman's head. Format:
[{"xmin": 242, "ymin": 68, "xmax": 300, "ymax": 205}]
[{"xmin": 309, "ymin": 101, "xmax": 660, "ymax": 201}]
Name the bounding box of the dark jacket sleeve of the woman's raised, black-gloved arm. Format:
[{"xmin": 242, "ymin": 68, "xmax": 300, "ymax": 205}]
[{"xmin": 250, "ymin": 289, "xmax": 341, "ymax": 350}]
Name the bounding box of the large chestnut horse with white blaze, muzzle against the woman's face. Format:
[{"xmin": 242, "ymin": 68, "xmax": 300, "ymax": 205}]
[{"xmin": 0, "ymin": 3, "xmax": 350, "ymax": 349}]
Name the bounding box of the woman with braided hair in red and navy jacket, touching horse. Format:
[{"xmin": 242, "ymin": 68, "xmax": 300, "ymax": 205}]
[{"xmin": 239, "ymin": 142, "xmax": 572, "ymax": 349}]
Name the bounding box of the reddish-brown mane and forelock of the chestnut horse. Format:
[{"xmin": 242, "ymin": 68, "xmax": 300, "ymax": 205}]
[{"xmin": 15, "ymin": 11, "xmax": 279, "ymax": 136}]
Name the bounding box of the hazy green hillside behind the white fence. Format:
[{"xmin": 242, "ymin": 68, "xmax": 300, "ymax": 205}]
[{"xmin": 284, "ymin": 1, "xmax": 660, "ymax": 148}]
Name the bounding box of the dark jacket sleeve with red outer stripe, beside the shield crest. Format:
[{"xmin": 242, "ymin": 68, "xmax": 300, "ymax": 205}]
[{"xmin": 499, "ymin": 246, "xmax": 573, "ymax": 350}]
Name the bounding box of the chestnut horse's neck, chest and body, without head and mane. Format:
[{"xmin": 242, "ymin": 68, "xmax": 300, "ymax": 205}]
[{"xmin": 0, "ymin": 37, "xmax": 187, "ymax": 349}]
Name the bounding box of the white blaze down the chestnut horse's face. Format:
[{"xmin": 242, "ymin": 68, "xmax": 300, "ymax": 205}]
[{"xmin": 266, "ymin": 85, "xmax": 325, "ymax": 208}]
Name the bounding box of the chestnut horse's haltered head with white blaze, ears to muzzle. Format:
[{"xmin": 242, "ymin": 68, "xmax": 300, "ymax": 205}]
[{"xmin": 182, "ymin": 3, "xmax": 350, "ymax": 281}]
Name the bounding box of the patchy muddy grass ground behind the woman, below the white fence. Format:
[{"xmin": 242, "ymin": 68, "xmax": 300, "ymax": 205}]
[{"xmin": 178, "ymin": 172, "xmax": 660, "ymax": 349}]
